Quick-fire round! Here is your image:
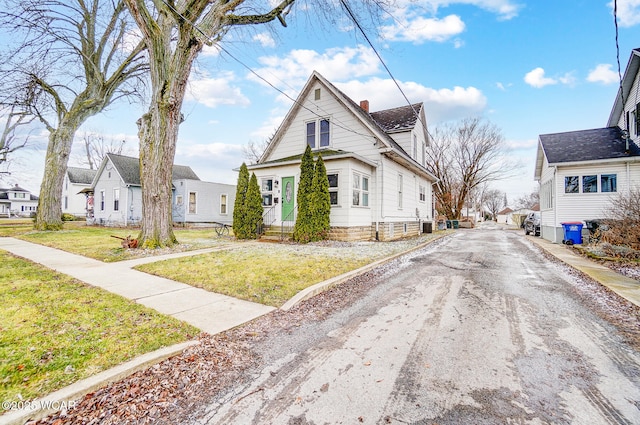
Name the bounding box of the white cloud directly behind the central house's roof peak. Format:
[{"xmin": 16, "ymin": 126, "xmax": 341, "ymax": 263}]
[{"xmin": 248, "ymin": 47, "xmax": 380, "ymax": 98}]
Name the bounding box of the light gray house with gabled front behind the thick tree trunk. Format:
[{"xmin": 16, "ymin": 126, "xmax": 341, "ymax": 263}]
[{"xmin": 88, "ymin": 153, "xmax": 235, "ymax": 226}]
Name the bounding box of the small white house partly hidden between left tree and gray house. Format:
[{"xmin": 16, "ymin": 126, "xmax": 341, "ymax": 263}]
[{"xmin": 62, "ymin": 167, "xmax": 97, "ymax": 217}]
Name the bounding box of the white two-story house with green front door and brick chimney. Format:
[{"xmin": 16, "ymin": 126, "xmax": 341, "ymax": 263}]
[{"xmin": 248, "ymin": 72, "xmax": 436, "ymax": 240}]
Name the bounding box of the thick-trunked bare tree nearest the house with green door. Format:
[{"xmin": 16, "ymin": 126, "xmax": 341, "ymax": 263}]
[{"xmin": 120, "ymin": 0, "xmax": 385, "ymax": 248}]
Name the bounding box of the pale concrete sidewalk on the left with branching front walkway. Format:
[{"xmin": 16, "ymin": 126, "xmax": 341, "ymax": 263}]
[{"xmin": 0, "ymin": 238, "xmax": 275, "ymax": 334}]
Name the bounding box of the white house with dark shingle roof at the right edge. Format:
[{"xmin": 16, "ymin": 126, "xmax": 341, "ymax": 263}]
[{"xmin": 535, "ymin": 49, "xmax": 640, "ymax": 242}]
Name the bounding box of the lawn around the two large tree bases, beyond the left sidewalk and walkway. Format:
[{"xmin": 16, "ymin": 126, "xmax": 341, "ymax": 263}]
[{"xmin": 11, "ymin": 222, "xmax": 230, "ymax": 262}]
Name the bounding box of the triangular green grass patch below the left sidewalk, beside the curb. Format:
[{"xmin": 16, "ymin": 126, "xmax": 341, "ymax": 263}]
[{"xmin": 0, "ymin": 251, "xmax": 199, "ymax": 404}]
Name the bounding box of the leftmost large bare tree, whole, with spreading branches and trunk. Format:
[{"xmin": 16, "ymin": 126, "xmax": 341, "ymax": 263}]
[{"xmin": 0, "ymin": 0, "xmax": 148, "ymax": 230}]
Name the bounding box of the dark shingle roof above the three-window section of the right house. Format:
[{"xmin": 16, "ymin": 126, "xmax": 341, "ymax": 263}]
[{"xmin": 540, "ymin": 127, "xmax": 640, "ymax": 164}]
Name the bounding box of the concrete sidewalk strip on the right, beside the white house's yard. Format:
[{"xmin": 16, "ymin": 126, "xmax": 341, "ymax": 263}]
[{"xmin": 527, "ymin": 236, "xmax": 640, "ymax": 307}]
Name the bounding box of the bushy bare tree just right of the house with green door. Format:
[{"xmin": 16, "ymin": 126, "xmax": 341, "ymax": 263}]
[{"xmin": 426, "ymin": 118, "xmax": 519, "ymax": 219}]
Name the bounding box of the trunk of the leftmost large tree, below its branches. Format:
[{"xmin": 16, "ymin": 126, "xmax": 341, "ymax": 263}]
[{"xmin": 34, "ymin": 120, "xmax": 80, "ymax": 230}]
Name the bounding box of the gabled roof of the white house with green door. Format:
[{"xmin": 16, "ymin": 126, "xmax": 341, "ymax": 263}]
[{"xmin": 256, "ymin": 71, "xmax": 437, "ymax": 181}]
